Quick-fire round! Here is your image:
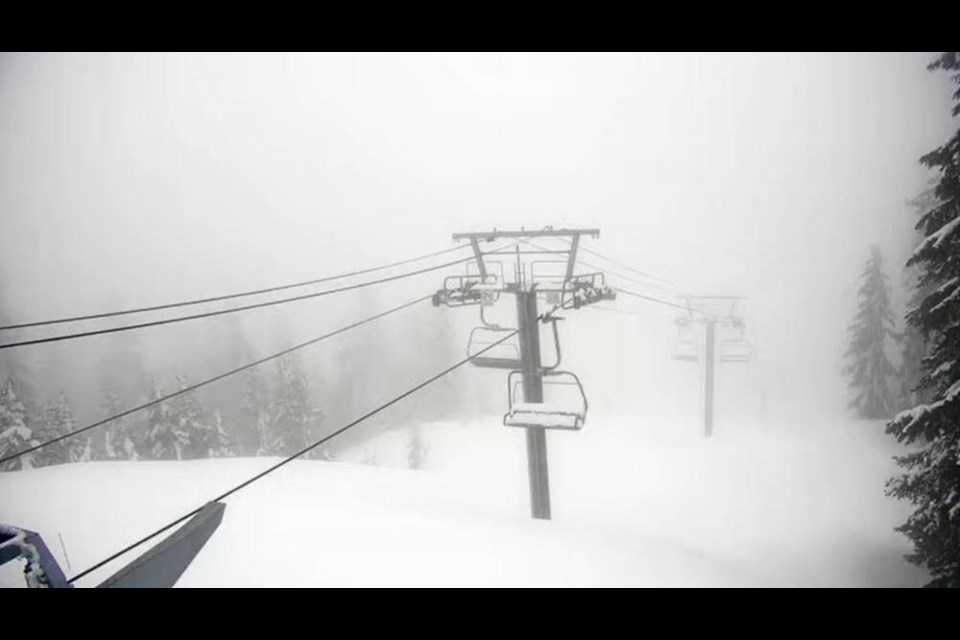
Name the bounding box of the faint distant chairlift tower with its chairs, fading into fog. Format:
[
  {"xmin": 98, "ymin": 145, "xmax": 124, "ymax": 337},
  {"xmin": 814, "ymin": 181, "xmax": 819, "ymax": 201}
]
[{"xmin": 673, "ymin": 296, "xmax": 753, "ymax": 438}]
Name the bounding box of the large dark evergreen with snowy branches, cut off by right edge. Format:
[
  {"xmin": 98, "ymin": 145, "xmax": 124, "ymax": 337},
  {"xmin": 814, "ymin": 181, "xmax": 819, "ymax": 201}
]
[{"xmin": 887, "ymin": 52, "xmax": 960, "ymax": 587}]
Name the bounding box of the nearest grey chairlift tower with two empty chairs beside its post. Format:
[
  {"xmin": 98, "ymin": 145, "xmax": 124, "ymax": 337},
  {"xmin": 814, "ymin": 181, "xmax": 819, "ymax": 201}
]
[{"xmin": 433, "ymin": 227, "xmax": 615, "ymax": 520}]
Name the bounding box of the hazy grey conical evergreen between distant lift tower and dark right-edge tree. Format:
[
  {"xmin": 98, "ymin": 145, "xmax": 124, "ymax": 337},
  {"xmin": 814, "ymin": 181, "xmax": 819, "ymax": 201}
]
[{"xmin": 844, "ymin": 246, "xmax": 899, "ymax": 420}]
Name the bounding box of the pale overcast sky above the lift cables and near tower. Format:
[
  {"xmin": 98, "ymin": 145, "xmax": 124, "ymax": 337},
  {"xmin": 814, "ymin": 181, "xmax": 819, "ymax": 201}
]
[{"xmin": 0, "ymin": 53, "xmax": 955, "ymax": 420}]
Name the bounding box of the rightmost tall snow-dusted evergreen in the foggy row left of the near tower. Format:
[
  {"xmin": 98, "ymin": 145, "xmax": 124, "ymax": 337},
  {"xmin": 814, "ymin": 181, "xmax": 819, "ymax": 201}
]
[{"xmin": 263, "ymin": 353, "xmax": 329, "ymax": 458}]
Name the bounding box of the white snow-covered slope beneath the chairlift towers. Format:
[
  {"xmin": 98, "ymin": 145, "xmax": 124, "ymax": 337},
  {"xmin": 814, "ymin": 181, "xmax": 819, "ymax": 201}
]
[{"xmin": 0, "ymin": 414, "xmax": 926, "ymax": 587}]
